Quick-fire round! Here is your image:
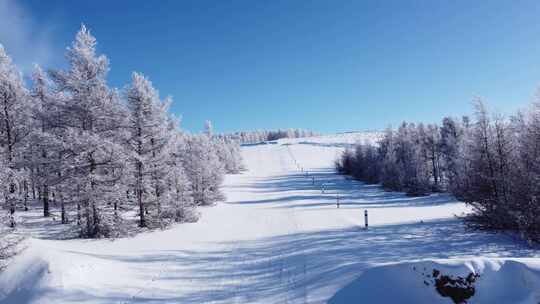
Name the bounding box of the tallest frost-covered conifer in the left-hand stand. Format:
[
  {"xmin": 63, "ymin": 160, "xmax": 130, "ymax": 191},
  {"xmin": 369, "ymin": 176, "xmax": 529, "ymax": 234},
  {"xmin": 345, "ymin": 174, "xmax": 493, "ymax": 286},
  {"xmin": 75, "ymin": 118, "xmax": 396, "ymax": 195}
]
[{"xmin": 48, "ymin": 25, "xmax": 126, "ymax": 237}]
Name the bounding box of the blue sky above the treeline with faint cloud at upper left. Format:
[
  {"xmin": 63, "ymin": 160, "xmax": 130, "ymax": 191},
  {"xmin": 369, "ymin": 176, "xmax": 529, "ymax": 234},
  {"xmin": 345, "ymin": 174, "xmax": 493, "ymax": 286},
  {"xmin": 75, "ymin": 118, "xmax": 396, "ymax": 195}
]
[{"xmin": 0, "ymin": 0, "xmax": 540, "ymax": 132}]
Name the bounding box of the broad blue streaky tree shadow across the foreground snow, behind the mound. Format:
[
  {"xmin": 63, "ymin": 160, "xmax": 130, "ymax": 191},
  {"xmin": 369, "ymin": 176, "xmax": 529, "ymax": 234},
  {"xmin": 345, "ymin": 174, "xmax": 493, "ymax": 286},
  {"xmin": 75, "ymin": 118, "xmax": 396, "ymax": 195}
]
[{"xmin": 35, "ymin": 220, "xmax": 535, "ymax": 303}]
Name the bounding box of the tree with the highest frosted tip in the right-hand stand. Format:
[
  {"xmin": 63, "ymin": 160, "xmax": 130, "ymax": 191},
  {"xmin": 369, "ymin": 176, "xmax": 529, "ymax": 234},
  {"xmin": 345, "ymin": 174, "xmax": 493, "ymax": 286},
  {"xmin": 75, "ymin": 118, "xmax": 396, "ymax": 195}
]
[{"xmin": 455, "ymin": 101, "xmax": 517, "ymax": 229}]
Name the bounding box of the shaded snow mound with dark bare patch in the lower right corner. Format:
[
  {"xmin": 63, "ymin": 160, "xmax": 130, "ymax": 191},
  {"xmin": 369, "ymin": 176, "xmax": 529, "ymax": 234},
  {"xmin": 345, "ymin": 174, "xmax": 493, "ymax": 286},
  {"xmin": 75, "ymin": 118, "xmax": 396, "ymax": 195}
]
[{"xmin": 328, "ymin": 259, "xmax": 540, "ymax": 304}]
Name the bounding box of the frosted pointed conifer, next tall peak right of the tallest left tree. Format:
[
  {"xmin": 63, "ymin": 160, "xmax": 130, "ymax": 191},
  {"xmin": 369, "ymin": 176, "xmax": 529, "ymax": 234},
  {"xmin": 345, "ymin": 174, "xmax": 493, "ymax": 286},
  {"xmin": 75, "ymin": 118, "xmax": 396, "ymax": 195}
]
[{"xmin": 126, "ymin": 73, "xmax": 179, "ymax": 227}]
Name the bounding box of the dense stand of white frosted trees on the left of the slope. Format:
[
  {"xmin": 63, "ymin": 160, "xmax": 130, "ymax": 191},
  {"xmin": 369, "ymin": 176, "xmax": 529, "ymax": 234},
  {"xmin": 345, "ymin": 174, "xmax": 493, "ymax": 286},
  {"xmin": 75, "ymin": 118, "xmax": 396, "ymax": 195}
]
[{"xmin": 0, "ymin": 25, "xmax": 242, "ymax": 250}]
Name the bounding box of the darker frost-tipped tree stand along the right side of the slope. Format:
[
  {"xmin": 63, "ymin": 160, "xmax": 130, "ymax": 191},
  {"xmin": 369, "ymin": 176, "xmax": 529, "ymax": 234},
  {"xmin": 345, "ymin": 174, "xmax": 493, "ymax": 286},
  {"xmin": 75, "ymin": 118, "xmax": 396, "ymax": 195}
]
[{"xmin": 336, "ymin": 100, "xmax": 540, "ymax": 241}]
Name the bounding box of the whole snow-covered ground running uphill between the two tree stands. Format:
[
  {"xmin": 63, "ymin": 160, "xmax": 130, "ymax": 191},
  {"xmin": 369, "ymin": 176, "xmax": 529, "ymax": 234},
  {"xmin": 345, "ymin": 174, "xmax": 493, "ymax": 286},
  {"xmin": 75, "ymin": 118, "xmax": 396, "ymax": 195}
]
[{"xmin": 0, "ymin": 133, "xmax": 540, "ymax": 304}]
